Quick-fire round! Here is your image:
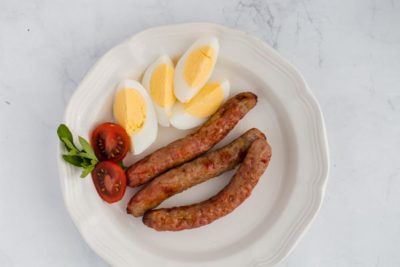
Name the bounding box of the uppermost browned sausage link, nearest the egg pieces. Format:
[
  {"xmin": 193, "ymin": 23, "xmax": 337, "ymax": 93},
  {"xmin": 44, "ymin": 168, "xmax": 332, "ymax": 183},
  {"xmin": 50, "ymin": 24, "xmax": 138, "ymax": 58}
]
[{"xmin": 126, "ymin": 92, "xmax": 257, "ymax": 187}]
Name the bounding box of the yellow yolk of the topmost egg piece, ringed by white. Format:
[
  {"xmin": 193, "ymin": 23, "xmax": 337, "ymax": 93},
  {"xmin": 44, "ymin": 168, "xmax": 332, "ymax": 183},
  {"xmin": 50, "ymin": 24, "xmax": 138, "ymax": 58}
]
[{"xmin": 183, "ymin": 46, "xmax": 215, "ymax": 87}]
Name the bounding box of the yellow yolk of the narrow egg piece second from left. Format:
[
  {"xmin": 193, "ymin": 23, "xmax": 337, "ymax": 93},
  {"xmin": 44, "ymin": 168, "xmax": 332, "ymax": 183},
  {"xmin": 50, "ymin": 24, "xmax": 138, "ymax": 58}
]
[{"xmin": 150, "ymin": 64, "xmax": 176, "ymax": 111}]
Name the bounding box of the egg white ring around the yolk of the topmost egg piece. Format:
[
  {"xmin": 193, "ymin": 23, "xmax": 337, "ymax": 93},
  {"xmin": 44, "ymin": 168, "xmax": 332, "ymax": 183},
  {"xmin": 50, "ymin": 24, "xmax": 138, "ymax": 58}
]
[{"xmin": 174, "ymin": 36, "xmax": 219, "ymax": 103}]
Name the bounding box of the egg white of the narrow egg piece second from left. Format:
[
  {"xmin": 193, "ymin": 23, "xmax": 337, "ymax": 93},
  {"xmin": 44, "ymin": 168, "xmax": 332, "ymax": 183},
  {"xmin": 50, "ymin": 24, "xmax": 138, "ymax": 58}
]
[{"xmin": 142, "ymin": 55, "xmax": 174, "ymax": 127}]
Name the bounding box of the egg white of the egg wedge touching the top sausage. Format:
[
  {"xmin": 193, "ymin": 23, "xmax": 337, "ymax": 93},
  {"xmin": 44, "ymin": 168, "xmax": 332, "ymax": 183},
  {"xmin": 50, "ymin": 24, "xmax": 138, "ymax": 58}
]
[{"xmin": 170, "ymin": 80, "xmax": 230, "ymax": 130}]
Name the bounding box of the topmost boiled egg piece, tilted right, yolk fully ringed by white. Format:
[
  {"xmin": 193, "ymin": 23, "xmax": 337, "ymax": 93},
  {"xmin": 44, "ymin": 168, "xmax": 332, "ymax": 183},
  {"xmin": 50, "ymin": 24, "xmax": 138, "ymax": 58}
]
[{"xmin": 174, "ymin": 37, "xmax": 219, "ymax": 103}]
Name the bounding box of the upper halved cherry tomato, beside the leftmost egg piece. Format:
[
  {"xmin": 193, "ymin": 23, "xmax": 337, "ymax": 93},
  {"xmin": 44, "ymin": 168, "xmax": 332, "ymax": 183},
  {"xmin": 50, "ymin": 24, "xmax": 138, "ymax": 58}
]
[{"xmin": 90, "ymin": 122, "xmax": 130, "ymax": 162}]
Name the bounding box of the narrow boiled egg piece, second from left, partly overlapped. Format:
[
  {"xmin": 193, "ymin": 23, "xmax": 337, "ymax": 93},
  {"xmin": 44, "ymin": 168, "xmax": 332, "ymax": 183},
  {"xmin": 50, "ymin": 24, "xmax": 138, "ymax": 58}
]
[{"xmin": 143, "ymin": 55, "xmax": 176, "ymax": 127}]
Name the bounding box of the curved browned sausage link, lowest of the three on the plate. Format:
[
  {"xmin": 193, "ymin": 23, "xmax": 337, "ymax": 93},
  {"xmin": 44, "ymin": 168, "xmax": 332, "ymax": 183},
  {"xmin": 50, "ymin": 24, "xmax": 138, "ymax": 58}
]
[{"xmin": 143, "ymin": 139, "xmax": 271, "ymax": 231}]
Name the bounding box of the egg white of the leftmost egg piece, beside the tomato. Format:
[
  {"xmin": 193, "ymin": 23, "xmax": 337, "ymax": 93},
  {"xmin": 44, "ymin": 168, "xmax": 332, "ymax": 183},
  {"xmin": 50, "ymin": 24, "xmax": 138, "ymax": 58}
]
[{"xmin": 117, "ymin": 80, "xmax": 158, "ymax": 155}]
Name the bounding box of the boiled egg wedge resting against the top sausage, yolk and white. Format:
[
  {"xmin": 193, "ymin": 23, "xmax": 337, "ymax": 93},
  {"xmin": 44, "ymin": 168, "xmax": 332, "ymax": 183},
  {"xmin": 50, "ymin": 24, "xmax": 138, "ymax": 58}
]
[{"xmin": 170, "ymin": 80, "xmax": 230, "ymax": 129}]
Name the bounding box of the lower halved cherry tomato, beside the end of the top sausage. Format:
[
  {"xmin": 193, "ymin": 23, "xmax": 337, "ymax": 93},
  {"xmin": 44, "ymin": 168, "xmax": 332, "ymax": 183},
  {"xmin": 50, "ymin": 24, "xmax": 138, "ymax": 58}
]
[{"xmin": 92, "ymin": 161, "xmax": 126, "ymax": 203}]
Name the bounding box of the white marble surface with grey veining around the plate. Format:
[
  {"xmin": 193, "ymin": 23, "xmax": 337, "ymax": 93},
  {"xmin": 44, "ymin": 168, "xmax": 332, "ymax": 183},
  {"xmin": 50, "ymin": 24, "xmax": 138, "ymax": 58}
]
[{"xmin": 0, "ymin": 0, "xmax": 400, "ymax": 267}]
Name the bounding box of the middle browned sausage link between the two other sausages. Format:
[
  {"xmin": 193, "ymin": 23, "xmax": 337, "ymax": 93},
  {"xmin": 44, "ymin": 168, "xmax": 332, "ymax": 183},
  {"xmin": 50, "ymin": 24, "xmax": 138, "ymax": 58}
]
[{"xmin": 127, "ymin": 128, "xmax": 265, "ymax": 217}]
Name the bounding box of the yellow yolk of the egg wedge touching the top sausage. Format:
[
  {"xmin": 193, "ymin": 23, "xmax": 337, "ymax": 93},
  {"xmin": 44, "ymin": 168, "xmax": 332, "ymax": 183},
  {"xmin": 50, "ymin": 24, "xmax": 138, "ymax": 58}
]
[{"xmin": 183, "ymin": 83, "xmax": 224, "ymax": 118}]
